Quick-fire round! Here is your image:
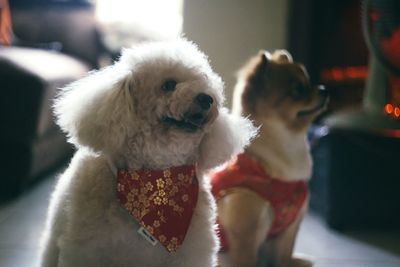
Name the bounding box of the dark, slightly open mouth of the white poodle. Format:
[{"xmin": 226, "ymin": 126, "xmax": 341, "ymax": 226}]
[{"xmin": 162, "ymin": 112, "xmax": 208, "ymax": 132}]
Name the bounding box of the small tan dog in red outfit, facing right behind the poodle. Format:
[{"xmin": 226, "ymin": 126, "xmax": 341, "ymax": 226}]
[{"xmin": 211, "ymin": 50, "xmax": 328, "ymax": 267}]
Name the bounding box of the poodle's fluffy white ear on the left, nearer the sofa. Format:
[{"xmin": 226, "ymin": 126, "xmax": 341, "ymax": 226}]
[{"xmin": 54, "ymin": 65, "xmax": 133, "ymax": 151}]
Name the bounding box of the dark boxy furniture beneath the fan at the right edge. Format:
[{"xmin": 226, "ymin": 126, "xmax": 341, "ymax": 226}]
[{"xmin": 310, "ymin": 126, "xmax": 400, "ymax": 230}]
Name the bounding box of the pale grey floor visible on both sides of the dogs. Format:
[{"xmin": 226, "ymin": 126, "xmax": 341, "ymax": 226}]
[{"xmin": 0, "ymin": 170, "xmax": 400, "ymax": 267}]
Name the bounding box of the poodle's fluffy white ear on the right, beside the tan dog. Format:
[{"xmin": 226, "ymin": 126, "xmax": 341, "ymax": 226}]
[{"xmin": 198, "ymin": 108, "xmax": 258, "ymax": 170}]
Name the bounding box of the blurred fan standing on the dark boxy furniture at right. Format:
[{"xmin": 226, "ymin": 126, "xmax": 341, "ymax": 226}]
[{"xmin": 326, "ymin": 0, "xmax": 400, "ymax": 129}]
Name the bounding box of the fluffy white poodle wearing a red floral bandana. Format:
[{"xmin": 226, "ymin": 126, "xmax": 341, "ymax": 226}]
[{"xmin": 41, "ymin": 39, "xmax": 256, "ymax": 267}]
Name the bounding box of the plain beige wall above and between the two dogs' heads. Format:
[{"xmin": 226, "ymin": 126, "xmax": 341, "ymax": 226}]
[{"xmin": 183, "ymin": 0, "xmax": 289, "ymax": 107}]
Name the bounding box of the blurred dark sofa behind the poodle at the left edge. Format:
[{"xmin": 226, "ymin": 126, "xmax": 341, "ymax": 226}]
[{"xmin": 0, "ymin": 0, "xmax": 104, "ymax": 198}]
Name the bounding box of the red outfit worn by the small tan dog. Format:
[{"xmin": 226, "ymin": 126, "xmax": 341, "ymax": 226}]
[{"xmin": 211, "ymin": 154, "xmax": 308, "ymax": 249}]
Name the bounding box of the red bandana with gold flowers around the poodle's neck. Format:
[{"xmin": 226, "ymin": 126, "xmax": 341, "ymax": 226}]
[{"xmin": 117, "ymin": 165, "xmax": 199, "ymax": 252}]
